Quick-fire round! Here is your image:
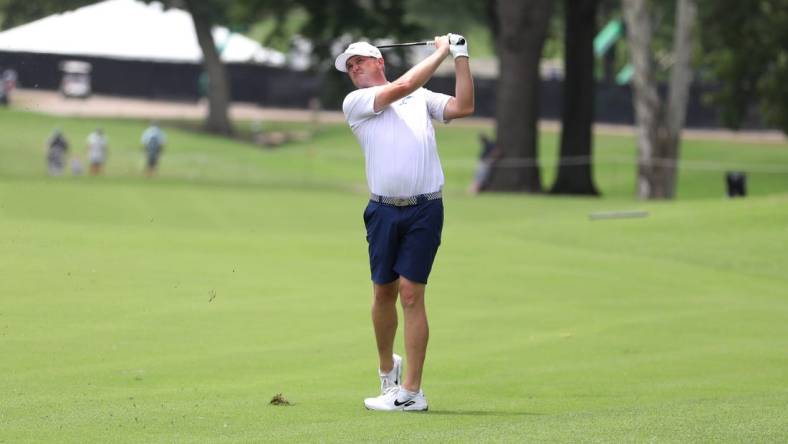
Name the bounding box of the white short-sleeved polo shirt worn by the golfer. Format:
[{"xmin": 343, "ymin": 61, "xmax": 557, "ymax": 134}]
[{"xmin": 342, "ymin": 85, "xmax": 451, "ymax": 197}]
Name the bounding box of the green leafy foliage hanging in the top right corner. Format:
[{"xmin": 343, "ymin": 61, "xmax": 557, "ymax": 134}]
[{"xmin": 699, "ymin": 0, "xmax": 788, "ymax": 134}]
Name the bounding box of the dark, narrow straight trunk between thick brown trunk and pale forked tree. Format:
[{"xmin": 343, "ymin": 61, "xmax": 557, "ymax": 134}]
[{"xmin": 550, "ymin": 0, "xmax": 599, "ymax": 196}]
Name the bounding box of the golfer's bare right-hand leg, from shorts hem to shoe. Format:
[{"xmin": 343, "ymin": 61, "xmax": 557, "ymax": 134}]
[{"xmin": 399, "ymin": 277, "xmax": 430, "ymax": 392}]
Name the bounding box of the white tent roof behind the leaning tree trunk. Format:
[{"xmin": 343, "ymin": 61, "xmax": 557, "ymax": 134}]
[{"xmin": 0, "ymin": 0, "xmax": 286, "ymax": 66}]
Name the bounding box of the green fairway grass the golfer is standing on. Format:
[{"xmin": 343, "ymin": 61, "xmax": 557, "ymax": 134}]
[{"xmin": 0, "ymin": 106, "xmax": 788, "ymax": 443}]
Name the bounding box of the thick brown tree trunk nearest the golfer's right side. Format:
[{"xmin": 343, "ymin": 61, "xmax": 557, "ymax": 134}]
[{"xmin": 487, "ymin": 0, "xmax": 553, "ymax": 193}]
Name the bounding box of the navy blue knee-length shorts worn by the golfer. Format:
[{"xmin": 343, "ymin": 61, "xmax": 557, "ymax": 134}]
[{"xmin": 364, "ymin": 199, "xmax": 443, "ymax": 284}]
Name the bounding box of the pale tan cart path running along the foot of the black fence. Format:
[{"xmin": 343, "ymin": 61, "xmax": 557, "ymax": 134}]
[{"xmin": 11, "ymin": 89, "xmax": 788, "ymax": 144}]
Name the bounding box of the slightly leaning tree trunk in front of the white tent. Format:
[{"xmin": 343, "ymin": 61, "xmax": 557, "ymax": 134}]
[{"xmin": 185, "ymin": 0, "xmax": 233, "ymax": 134}]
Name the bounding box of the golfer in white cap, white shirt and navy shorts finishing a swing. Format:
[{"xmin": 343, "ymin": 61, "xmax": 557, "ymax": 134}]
[{"xmin": 335, "ymin": 34, "xmax": 474, "ymax": 411}]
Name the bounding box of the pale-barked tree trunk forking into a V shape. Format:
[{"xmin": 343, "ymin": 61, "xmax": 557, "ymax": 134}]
[{"xmin": 623, "ymin": 0, "xmax": 697, "ymax": 199}]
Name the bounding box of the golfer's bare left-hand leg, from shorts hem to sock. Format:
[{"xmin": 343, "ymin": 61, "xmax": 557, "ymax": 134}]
[{"xmin": 372, "ymin": 280, "xmax": 399, "ymax": 373}]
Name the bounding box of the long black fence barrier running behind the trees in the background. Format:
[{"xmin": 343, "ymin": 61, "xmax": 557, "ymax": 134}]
[{"xmin": 0, "ymin": 51, "xmax": 764, "ymax": 129}]
